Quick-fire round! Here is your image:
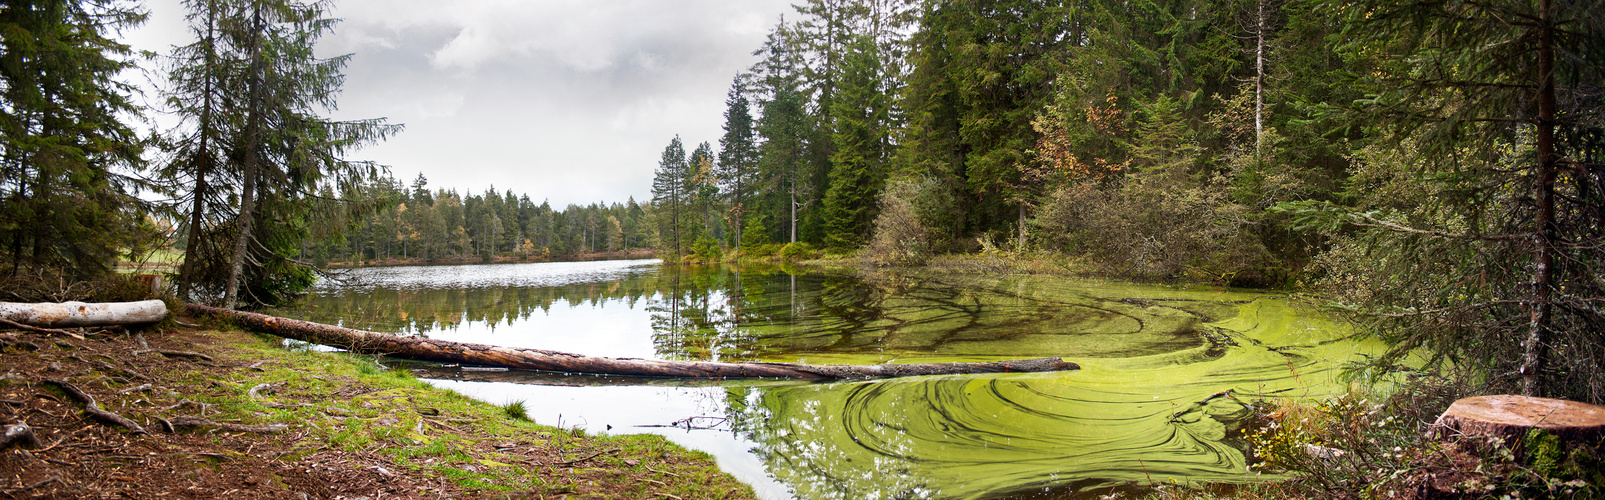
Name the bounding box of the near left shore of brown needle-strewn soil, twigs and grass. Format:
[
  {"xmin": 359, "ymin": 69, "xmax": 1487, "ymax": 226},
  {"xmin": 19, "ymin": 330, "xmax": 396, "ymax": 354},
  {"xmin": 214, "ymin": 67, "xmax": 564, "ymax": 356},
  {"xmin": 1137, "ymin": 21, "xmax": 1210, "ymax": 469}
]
[{"xmin": 0, "ymin": 314, "xmax": 753, "ymax": 500}]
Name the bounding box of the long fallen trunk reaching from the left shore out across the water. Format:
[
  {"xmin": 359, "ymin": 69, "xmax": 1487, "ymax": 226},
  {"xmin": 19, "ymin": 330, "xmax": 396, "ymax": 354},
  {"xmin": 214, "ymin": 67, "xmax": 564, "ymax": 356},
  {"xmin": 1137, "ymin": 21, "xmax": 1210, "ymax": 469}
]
[{"xmin": 188, "ymin": 304, "xmax": 1080, "ymax": 381}]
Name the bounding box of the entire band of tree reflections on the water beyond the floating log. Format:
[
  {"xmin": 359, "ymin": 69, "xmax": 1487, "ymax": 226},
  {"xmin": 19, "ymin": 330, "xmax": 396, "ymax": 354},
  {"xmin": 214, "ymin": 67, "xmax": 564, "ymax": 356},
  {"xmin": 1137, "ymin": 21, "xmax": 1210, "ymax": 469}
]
[{"xmin": 301, "ymin": 266, "xmax": 1219, "ymax": 362}]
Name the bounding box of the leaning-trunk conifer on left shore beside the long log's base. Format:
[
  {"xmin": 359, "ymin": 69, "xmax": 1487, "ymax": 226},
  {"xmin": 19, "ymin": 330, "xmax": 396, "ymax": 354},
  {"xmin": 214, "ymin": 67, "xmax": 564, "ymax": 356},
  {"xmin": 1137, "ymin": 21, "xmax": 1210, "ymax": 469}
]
[{"xmin": 169, "ymin": 0, "xmax": 400, "ymax": 308}]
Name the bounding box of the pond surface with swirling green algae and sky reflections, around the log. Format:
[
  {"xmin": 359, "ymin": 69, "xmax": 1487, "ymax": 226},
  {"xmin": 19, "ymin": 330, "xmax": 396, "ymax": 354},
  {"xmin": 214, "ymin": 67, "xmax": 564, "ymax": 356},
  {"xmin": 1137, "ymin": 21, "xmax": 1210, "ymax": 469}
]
[{"xmin": 284, "ymin": 261, "xmax": 1379, "ymax": 498}]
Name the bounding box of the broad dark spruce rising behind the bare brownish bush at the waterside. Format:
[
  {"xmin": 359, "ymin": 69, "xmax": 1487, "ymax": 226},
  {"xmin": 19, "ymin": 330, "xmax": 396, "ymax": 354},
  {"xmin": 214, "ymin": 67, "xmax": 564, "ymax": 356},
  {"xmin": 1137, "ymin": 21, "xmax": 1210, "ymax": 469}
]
[{"xmin": 899, "ymin": 0, "xmax": 1080, "ymax": 231}]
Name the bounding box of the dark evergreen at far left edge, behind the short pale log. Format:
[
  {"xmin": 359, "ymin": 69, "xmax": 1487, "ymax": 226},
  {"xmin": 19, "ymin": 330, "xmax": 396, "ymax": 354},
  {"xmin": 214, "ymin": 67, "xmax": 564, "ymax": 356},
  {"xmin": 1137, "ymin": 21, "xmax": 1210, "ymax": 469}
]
[{"xmin": 0, "ymin": 0, "xmax": 144, "ymax": 277}]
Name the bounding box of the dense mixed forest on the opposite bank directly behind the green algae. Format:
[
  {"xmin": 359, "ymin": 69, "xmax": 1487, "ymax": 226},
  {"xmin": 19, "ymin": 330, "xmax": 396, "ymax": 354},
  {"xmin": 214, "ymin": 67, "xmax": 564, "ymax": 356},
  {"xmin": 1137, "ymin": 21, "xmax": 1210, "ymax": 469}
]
[{"xmin": 638, "ymin": 0, "xmax": 1371, "ymax": 285}]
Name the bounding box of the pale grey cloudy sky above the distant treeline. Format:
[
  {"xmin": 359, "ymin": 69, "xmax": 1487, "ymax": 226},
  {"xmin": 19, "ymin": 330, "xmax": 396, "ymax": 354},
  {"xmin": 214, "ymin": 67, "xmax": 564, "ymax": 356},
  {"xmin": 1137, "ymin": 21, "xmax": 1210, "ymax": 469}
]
[{"xmin": 125, "ymin": 0, "xmax": 791, "ymax": 208}]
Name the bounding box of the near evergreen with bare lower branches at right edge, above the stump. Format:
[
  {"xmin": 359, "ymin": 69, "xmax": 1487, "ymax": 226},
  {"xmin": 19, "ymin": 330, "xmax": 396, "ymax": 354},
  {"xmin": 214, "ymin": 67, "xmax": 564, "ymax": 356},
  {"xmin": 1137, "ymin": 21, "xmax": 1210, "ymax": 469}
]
[{"xmin": 1289, "ymin": 0, "xmax": 1605, "ymax": 402}]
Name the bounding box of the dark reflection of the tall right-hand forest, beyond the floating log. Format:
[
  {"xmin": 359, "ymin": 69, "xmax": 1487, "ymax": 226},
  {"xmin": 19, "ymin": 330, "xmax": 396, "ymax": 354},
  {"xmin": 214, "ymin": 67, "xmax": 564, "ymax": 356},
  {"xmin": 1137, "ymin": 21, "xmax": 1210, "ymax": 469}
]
[{"xmin": 652, "ymin": 268, "xmax": 1201, "ymax": 361}]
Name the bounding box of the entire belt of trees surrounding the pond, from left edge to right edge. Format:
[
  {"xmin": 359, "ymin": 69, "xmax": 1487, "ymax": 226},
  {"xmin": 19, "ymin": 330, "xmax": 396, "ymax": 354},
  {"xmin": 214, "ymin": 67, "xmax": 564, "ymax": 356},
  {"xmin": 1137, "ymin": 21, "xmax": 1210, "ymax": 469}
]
[{"xmin": 0, "ymin": 0, "xmax": 1605, "ymax": 402}]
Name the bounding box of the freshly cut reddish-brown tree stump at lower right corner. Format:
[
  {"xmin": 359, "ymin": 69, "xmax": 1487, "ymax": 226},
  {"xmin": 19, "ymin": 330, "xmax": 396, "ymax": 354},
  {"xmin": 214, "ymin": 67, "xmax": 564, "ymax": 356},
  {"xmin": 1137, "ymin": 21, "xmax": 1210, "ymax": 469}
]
[{"xmin": 1427, "ymin": 394, "xmax": 1605, "ymax": 457}]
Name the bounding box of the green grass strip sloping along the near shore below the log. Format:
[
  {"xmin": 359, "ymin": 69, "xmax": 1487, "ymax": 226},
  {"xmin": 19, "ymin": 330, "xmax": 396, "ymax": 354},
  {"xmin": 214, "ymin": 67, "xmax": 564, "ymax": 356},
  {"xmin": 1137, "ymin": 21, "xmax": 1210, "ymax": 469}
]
[{"xmin": 164, "ymin": 330, "xmax": 753, "ymax": 498}]
